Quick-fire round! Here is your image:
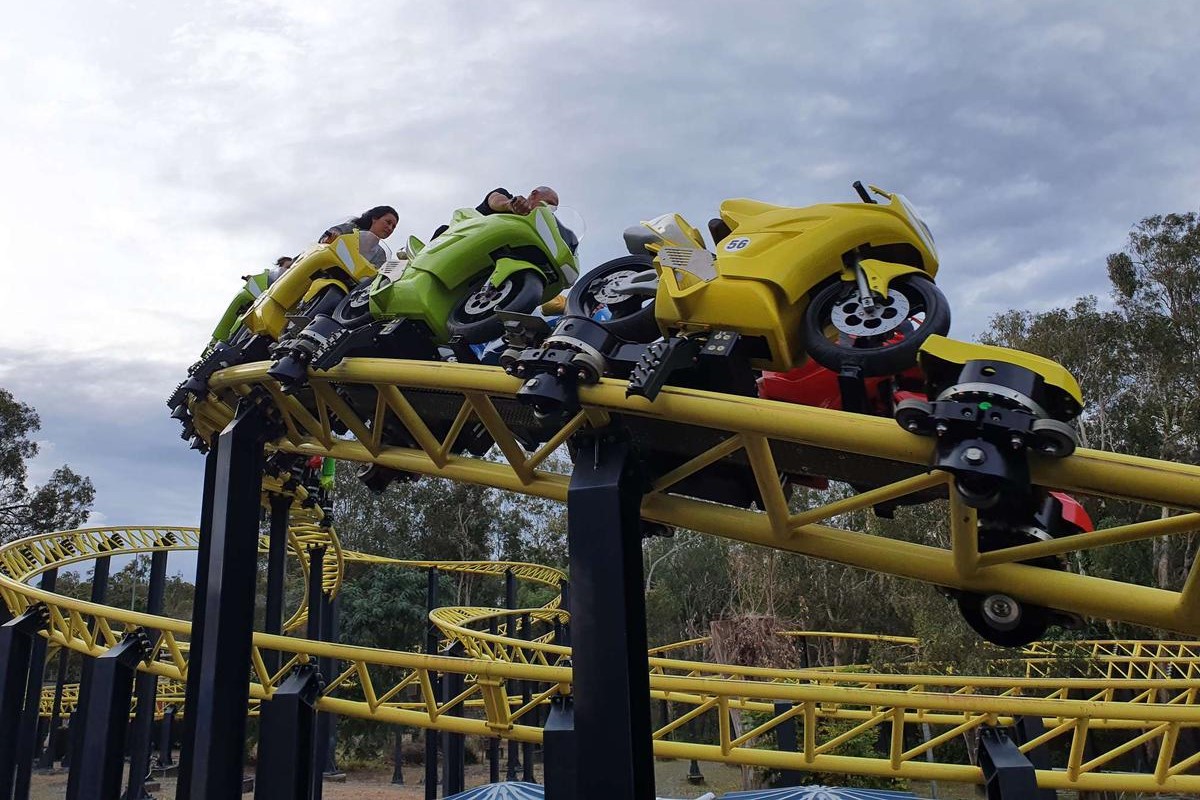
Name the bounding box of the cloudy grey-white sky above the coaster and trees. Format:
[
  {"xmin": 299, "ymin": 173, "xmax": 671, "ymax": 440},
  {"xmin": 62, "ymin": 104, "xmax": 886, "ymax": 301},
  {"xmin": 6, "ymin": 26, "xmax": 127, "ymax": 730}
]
[{"xmin": 0, "ymin": 0, "xmax": 1200, "ymax": 532}]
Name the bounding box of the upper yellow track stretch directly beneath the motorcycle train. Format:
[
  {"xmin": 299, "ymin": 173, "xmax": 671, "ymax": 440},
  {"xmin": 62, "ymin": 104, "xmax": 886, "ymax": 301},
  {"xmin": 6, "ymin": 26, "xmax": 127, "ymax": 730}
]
[{"xmin": 184, "ymin": 359, "xmax": 1200, "ymax": 634}]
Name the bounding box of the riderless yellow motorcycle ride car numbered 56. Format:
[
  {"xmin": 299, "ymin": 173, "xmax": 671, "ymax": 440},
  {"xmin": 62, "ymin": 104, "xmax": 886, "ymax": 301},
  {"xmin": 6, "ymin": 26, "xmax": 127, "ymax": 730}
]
[{"xmin": 511, "ymin": 184, "xmax": 950, "ymax": 414}]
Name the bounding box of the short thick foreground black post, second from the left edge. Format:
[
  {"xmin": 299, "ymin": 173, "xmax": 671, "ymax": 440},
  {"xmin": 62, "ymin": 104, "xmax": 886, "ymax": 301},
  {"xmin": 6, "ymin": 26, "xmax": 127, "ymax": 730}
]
[{"xmin": 72, "ymin": 628, "xmax": 152, "ymax": 800}]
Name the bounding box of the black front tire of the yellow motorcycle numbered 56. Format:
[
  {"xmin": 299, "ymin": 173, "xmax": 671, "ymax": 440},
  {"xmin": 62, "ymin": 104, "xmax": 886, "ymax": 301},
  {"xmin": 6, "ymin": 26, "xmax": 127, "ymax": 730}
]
[{"xmin": 803, "ymin": 273, "xmax": 950, "ymax": 378}]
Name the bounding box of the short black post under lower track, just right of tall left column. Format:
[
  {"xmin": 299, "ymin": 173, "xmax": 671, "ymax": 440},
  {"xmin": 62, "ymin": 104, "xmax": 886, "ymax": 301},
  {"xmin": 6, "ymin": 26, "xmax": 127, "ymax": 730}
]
[{"xmin": 254, "ymin": 664, "xmax": 320, "ymax": 800}]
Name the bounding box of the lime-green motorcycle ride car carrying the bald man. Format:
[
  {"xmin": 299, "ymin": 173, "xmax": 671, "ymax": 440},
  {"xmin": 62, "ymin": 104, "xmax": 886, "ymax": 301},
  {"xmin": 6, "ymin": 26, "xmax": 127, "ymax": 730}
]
[{"xmin": 268, "ymin": 204, "xmax": 582, "ymax": 390}]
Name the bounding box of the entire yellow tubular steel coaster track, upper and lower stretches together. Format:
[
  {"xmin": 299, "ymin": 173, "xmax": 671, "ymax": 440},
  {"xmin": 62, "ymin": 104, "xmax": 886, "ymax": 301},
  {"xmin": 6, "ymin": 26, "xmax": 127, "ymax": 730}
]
[{"xmin": 11, "ymin": 359, "xmax": 1200, "ymax": 793}]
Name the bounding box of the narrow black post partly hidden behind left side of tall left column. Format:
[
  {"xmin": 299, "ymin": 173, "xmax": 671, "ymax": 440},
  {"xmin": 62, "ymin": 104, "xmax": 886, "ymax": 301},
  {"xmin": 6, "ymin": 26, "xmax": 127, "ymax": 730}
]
[{"xmin": 175, "ymin": 437, "xmax": 221, "ymax": 800}]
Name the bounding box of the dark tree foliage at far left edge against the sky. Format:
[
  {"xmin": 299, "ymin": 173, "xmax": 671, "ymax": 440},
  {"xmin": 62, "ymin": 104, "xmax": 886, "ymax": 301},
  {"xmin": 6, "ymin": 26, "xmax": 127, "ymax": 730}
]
[{"xmin": 0, "ymin": 389, "xmax": 96, "ymax": 542}]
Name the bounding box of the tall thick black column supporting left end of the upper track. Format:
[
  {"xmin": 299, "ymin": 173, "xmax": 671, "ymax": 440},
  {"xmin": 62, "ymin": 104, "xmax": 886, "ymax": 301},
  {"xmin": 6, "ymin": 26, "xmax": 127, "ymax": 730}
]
[{"xmin": 178, "ymin": 401, "xmax": 266, "ymax": 800}]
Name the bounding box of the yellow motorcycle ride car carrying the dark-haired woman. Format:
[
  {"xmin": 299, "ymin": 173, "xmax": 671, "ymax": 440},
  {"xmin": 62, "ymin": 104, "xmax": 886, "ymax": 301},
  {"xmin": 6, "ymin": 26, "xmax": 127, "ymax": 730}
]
[{"xmin": 167, "ymin": 230, "xmax": 379, "ymax": 449}]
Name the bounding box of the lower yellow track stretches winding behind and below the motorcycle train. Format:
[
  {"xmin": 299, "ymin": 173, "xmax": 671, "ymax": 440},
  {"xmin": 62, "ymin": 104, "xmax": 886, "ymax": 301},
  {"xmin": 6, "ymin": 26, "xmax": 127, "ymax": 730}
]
[{"xmin": 7, "ymin": 528, "xmax": 1200, "ymax": 793}]
